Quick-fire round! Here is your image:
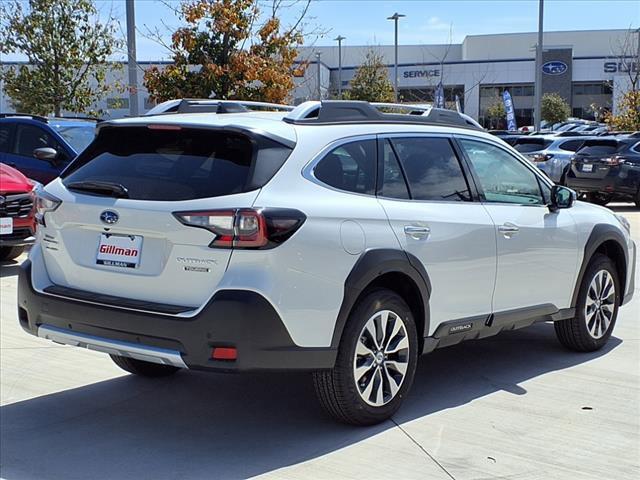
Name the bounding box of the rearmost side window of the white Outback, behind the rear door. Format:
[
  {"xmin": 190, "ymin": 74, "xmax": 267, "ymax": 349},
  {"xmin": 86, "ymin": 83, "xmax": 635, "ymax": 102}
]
[{"xmin": 313, "ymin": 140, "xmax": 376, "ymax": 195}]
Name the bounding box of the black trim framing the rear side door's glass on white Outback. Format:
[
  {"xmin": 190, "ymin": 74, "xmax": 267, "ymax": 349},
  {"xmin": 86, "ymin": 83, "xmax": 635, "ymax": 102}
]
[{"xmin": 376, "ymin": 132, "xmax": 480, "ymax": 205}]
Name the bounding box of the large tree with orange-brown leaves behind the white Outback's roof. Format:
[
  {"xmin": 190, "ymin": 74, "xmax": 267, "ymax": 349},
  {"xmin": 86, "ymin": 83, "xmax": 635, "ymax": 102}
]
[{"xmin": 144, "ymin": 0, "xmax": 310, "ymax": 103}]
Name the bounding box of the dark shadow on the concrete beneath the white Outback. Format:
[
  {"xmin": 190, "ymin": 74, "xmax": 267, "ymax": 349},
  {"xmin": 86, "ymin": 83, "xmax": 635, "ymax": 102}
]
[{"xmin": 0, "ymin": 324, "xmax": 621, "ymax": 480}]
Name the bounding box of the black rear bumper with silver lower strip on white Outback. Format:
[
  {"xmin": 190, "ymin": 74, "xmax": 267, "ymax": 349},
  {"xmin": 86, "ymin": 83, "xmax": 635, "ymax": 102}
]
[{"xmin": 18, "ymin": 260, "xmax": 337, "ymax": 372}]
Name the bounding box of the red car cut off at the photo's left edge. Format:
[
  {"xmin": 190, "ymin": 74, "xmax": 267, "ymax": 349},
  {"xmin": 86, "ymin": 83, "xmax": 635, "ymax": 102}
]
[{"xmin": 0, "ymin": 163, "xmax": 36, "ymax": 261}]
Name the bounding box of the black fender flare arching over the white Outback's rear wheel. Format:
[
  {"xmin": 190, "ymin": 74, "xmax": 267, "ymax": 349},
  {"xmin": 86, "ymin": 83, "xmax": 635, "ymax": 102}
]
[{"xmin": 331, "ymin": 249, "xmax": 431, "ymax": 348}]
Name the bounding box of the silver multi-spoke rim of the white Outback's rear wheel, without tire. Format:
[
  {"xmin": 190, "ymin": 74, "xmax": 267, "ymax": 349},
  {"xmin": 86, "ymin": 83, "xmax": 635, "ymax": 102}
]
[{"xmin": 353, "ymin": 310, "xmax": 409, "ymax": 407}]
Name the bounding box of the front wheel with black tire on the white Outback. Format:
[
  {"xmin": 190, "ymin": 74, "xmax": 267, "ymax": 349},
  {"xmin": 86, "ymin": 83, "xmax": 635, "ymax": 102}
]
[{"xmin": 554, "ymin": 253, "xmax": 621, "ymax": 352}]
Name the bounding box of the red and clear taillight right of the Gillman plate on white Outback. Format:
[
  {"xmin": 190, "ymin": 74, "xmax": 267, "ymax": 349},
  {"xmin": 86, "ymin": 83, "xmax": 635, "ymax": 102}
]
[{"xmin": 173, "ymin": 208, "xmax": 306, "ymax": 249}]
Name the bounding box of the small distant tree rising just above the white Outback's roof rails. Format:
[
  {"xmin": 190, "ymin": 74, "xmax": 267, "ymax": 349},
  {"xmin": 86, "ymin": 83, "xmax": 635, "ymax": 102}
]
[{"xmin": 344, "ymin": 49, "xmax": 395, "ymax": 102}]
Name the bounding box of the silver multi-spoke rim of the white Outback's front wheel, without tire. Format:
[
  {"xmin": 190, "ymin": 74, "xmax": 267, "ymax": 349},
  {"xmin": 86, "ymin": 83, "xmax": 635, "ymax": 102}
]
[{"xmin": 584, "ymin": 270, "xmax": 616, "ymax": 339}]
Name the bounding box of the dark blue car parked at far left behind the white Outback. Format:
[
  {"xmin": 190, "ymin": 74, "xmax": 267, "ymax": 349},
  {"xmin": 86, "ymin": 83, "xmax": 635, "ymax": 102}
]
[{"xmin": 0, "ymin": 114, "xmax": 96, "ymax": 184}]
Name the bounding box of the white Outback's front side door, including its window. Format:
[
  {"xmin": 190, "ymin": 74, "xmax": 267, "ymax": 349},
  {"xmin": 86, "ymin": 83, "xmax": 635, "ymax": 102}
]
[{"xmin": 458, "ymin": 137, "xmax": 578, "ymax": 313}]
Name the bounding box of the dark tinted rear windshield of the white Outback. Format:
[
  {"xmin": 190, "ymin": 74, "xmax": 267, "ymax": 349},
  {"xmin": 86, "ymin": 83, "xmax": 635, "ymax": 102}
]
[{"xmin": 62, "ymin": 126, "xmax": 291, "ymax": 201}]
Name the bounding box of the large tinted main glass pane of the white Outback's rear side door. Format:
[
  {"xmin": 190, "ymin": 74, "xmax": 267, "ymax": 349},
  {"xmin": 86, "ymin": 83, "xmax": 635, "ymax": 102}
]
[{"xmin": 391, "ymin": 137, "xmax": 471, "ymax": 202}]
